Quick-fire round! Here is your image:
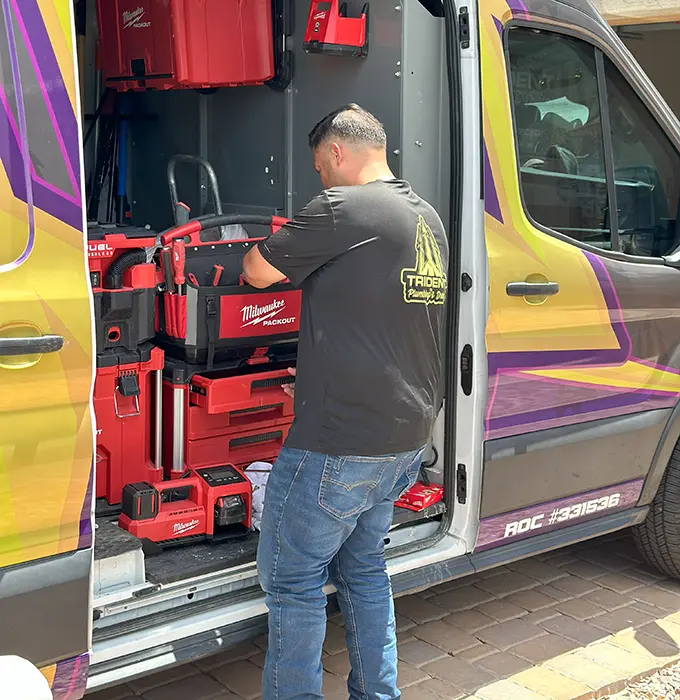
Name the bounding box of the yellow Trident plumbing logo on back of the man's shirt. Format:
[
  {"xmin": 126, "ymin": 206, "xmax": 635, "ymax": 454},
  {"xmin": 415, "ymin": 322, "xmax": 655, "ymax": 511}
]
[{"xmin": 401, "ymin": 216, "xmax": 446, "ymax": 304}]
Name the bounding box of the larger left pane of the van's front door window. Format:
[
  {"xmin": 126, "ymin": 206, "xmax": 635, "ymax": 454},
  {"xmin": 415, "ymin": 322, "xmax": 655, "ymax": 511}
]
[{"xmin": 508, "ymin": 28, "xmax": 611, "ymax": 249}]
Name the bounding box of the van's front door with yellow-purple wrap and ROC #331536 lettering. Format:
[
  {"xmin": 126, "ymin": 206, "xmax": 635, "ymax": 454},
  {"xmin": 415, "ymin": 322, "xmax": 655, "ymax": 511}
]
[{"xmin": 477, "ymin": 0, "xmax": 680, "ymax": 551}]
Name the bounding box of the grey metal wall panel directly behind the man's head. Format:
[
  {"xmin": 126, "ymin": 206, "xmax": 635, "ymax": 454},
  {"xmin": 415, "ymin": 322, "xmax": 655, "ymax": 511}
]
[{"xmin": 292, "ymin": 0, "xmax": 403, "ymax": 211}]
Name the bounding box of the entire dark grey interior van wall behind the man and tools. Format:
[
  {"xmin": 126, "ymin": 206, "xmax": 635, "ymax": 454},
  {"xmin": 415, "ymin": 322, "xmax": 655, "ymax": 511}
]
[{"xmin": 97, "ymin": 0, "xmax": 448, "ymax": 230}]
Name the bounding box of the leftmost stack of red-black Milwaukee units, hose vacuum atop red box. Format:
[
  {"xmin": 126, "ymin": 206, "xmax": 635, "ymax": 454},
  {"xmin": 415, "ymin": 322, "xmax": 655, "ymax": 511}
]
[{"xmin": 88, "ymin": 225, "xmax": 164, "ymax": 512}]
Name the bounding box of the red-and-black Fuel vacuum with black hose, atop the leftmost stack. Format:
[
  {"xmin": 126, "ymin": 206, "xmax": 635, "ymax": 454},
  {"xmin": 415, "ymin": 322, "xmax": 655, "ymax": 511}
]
[{"xmin": 87, "ymin": 225, "xmax": 157, "ymax": 353}]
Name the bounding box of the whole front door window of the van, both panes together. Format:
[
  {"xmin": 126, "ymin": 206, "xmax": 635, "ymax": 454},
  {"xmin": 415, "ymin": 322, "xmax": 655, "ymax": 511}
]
[{"xmin": 508, "ymin": 27, "xmax": 680, "ymax": 257}]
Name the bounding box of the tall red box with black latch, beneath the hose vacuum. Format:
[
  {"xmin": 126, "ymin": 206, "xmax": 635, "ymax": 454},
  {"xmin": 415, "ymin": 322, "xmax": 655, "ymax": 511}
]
[{"xmin": 94, "ymin": 343, "xmax": 164, "ymax": 506}]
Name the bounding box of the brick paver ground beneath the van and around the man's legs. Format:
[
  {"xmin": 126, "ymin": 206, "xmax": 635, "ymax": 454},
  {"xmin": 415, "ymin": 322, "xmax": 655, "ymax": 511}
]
[{"xmin": 87, "ymin": 534, "xmax": 680, "ymax": 700}]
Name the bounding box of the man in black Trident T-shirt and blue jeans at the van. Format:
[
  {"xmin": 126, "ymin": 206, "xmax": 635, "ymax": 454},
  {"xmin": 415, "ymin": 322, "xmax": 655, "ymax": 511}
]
[{"xmin": 243, "ymin": 105, "xmax": 448, "ymax": 700}]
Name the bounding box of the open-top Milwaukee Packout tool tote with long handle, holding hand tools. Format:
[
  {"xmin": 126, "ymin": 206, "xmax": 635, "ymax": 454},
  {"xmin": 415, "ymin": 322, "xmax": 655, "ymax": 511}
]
[{"xmin": 157, "ymin": 215, "xmax": 301, "ymax": 369}]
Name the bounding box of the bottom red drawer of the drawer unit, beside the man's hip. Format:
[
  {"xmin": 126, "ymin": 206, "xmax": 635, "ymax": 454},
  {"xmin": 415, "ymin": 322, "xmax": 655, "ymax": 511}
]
[{"xmin": 185, "ymin": 420, "xmax": 292, "ymax": 469}]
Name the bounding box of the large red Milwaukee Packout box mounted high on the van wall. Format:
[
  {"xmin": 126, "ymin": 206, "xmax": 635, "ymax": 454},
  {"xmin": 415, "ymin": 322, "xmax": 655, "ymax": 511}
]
[{"xmin": 97, "ymin": 0, "xmax": 275, "ymax": 90}]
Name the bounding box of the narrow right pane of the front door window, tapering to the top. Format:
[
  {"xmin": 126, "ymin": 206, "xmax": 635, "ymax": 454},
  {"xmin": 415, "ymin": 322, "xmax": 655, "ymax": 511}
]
[{"xmin": 605, "ymin": 58, "xmax": 680, "ymax": 257}]
